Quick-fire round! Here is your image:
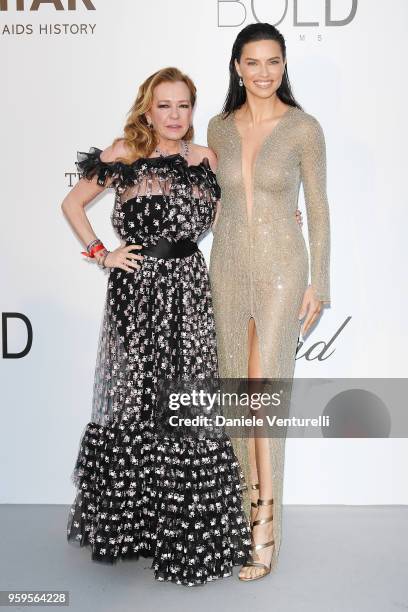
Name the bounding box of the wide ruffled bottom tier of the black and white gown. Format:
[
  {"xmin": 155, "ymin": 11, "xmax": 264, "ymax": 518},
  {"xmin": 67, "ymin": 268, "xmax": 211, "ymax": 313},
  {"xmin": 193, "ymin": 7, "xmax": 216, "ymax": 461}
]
[{"xmin": 67, "ymin": 414, "xmax": 250, "ymax": 586}]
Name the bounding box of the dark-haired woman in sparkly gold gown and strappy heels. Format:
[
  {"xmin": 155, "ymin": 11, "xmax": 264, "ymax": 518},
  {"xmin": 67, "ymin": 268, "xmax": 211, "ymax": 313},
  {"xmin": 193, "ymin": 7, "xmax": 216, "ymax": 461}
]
[{"xmin": 208, "ymin": 23, "xmax": 330, "ymax": 580}]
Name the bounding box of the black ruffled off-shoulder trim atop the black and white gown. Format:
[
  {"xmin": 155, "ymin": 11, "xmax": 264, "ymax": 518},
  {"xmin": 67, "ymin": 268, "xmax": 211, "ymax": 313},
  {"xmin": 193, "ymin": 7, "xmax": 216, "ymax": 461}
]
[{"xmin": 75, "ymin": 147, "xmax": 221, "ymax": 200}]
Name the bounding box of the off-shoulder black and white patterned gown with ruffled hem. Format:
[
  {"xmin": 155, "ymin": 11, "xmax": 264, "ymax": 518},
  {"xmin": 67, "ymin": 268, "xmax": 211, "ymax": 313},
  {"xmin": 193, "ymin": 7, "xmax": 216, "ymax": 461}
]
[{"xmin": 67, "ymin": 147, "xmax": 250, "ymax": 586}]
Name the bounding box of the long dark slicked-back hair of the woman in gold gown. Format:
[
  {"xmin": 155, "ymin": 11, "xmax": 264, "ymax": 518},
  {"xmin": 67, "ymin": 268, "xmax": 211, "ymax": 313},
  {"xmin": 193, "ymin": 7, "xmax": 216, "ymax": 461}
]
[{"xmin": 222, "ymin": 23, "xmax": 303, "ymax": 118}]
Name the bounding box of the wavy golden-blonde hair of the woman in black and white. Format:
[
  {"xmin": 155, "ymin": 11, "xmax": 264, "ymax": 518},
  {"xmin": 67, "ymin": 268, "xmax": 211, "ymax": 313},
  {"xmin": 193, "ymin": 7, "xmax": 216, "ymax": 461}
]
[{"xmin": 112, "ymin": 67, "xmax": 197, "ymax": 163}]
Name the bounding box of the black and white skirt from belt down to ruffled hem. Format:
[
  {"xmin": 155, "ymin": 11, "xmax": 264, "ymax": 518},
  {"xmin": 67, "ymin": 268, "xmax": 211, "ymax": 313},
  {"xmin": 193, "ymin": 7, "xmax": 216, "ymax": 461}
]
[{"xmin": 67, "ymin": 237, "xmax": 251, "ymax": 586}]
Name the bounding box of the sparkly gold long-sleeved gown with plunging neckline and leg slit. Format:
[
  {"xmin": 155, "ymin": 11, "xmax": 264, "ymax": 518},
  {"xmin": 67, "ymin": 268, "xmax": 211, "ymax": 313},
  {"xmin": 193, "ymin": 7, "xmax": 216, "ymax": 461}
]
[{"xmin": 208, "ymin": 107, "xmax": 330, "ymax": 568}]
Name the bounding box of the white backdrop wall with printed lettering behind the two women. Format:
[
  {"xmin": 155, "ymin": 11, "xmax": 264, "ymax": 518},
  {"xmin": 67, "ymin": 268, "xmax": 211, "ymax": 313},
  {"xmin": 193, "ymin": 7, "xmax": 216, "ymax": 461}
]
[{"xmin": 0, "ymin": 0, "xmax": 408, "ymax": 504}]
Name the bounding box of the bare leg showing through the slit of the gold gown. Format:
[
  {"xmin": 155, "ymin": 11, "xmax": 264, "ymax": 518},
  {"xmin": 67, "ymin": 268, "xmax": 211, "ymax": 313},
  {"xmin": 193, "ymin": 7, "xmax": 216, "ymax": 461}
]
[{"xmin": 239, "ymin": 318, "xmax": 273, "ymax": 578}]
